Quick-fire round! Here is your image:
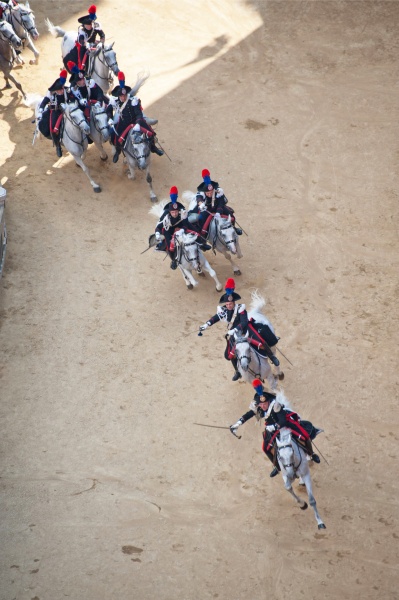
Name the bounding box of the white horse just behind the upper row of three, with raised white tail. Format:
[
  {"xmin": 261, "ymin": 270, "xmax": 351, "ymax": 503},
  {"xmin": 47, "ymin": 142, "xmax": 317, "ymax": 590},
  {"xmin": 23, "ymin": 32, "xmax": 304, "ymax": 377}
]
[{"xmin": 45, "ymin": 19, "xmax": 120, "ymax": 94}]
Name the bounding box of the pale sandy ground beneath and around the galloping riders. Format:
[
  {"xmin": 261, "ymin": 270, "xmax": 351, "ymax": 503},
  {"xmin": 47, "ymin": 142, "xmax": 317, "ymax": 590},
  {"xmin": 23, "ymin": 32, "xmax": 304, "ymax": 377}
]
[{"xmin": 0, "ymin": 0, "xmax": 399, "ymax": 600}]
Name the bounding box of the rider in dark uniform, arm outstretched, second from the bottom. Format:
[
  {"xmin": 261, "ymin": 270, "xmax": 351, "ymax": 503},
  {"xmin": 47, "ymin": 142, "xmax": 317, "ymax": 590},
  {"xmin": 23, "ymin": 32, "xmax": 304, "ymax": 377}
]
[{"xmin": 200, "ymin": 279, "xmax": 248, "ymax": 381}]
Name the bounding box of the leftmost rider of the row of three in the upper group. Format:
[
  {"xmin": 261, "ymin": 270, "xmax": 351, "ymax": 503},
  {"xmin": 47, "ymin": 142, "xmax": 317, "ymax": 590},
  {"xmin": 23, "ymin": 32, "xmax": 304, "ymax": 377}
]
[{"xmin": 37, "ymin": 69, "xmax": 69, "ymax": 158}]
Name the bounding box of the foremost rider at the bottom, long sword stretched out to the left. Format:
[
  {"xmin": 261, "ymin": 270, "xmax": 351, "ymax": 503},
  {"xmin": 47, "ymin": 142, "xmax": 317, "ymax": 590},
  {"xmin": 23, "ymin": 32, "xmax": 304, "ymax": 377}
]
[{"xmin": 230, "ymin": 379, "xmax": 323, "ymax": 477}]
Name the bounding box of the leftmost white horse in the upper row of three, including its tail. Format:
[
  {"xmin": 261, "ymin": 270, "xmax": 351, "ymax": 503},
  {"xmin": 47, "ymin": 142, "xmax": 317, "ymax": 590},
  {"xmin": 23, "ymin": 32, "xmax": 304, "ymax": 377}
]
[{"xmin": 25, "ymin": 94, "xmax": 101, "ymax": 192}]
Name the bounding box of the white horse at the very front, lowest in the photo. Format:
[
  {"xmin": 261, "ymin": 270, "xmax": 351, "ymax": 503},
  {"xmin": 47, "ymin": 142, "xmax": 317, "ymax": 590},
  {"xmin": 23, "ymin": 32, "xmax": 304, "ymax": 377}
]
[{"xmin": 276, "ymin": 427, "xmax": 326, "ymax": 529}]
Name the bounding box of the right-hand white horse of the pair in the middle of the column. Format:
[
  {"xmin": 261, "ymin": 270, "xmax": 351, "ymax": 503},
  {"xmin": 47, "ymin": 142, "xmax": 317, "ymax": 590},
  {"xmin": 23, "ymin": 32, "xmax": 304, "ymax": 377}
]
[{"xmin": 182, "ymin": 191, "xmax": 243, "ymax": 275}]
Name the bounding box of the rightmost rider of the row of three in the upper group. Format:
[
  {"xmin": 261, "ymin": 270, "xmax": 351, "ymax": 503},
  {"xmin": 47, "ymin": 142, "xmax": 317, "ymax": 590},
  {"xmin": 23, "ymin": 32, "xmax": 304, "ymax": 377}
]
[{"xmin": 109, "ymin": 71, "xmax": 164, "ymax": 163}]
